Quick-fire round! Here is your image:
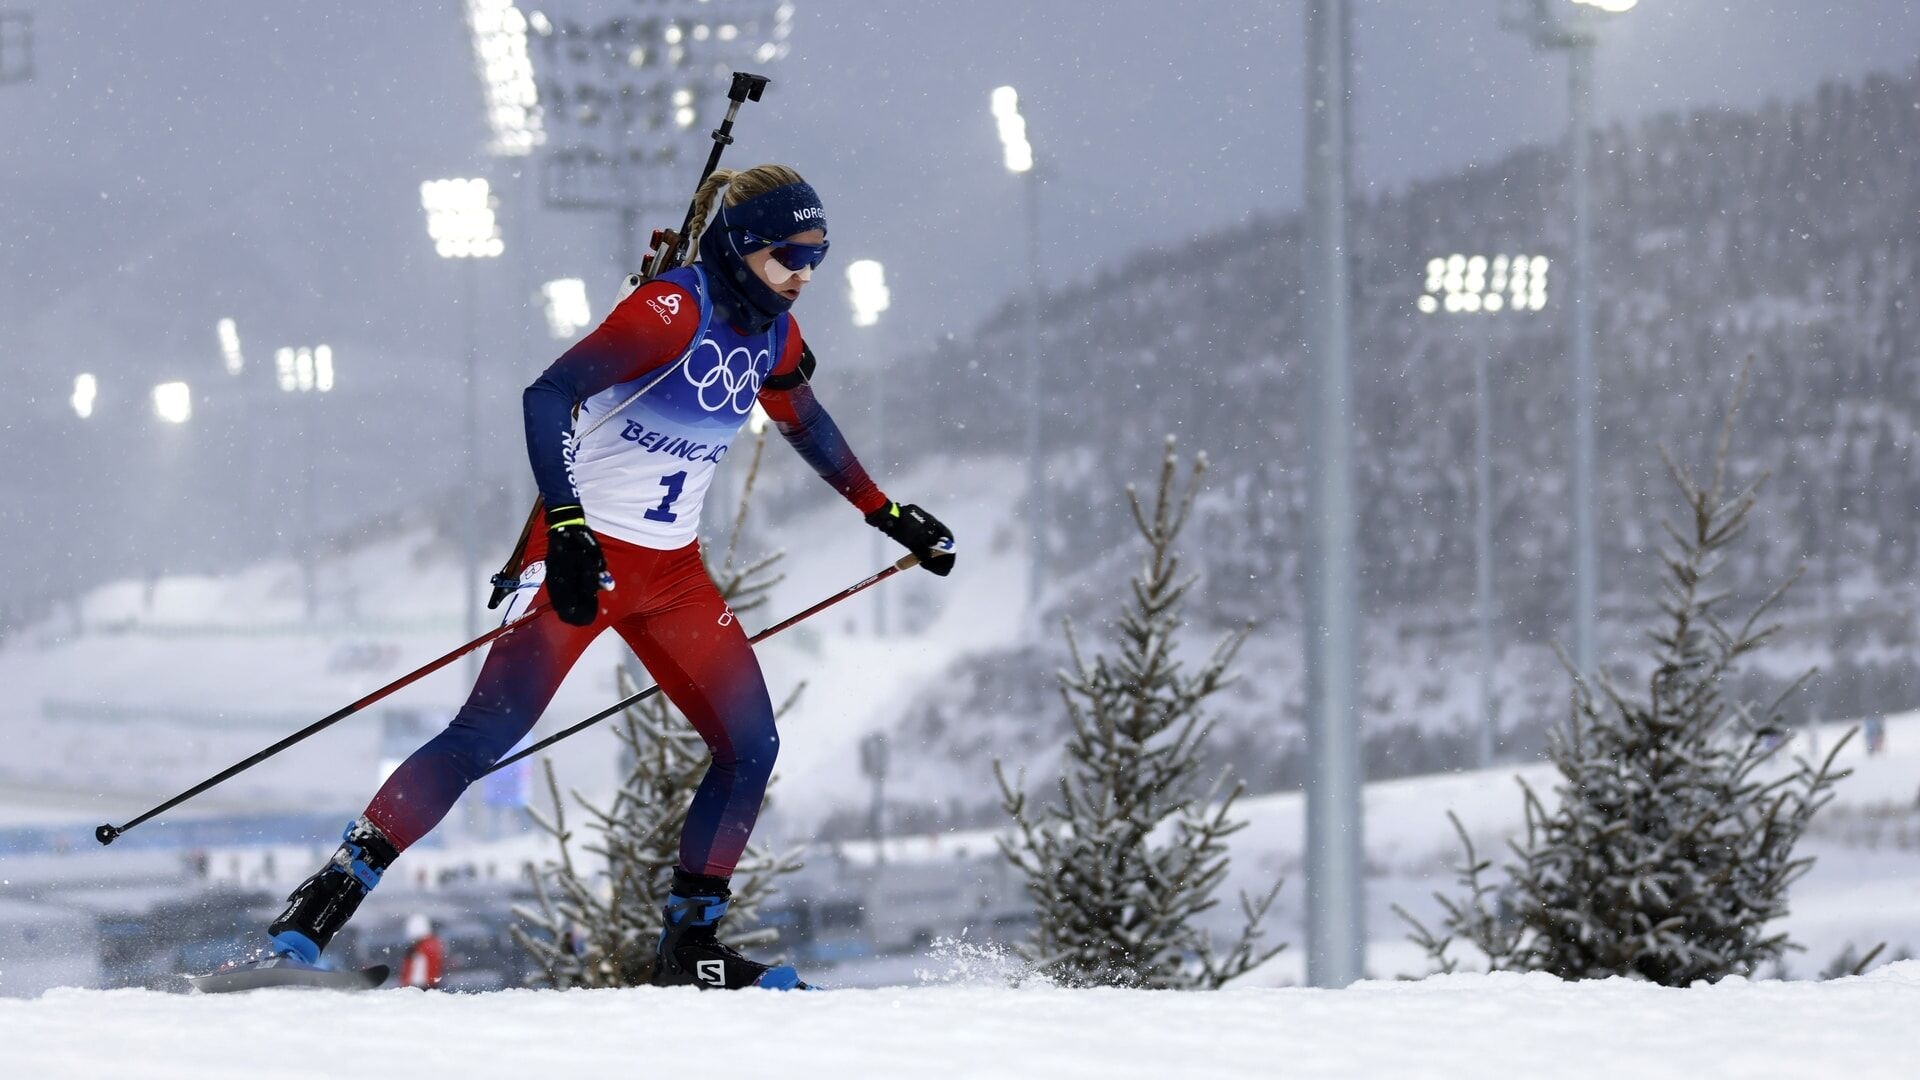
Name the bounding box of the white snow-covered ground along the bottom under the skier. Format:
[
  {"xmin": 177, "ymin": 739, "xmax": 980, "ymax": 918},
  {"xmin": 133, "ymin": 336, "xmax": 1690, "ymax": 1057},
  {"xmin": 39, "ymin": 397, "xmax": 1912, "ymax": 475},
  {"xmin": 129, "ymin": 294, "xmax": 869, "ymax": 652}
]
[{"xmin": 0, "ymin": 961, "xmax": 1920, "ymax": 1080}]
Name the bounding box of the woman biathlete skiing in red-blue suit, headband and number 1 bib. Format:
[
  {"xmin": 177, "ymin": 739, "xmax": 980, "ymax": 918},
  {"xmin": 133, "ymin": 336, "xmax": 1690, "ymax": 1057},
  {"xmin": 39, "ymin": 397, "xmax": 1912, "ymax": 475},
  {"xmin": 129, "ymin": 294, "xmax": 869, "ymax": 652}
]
[{"xmin": 267, "ymin": 165, "xmax": 954, "ymax": 988}]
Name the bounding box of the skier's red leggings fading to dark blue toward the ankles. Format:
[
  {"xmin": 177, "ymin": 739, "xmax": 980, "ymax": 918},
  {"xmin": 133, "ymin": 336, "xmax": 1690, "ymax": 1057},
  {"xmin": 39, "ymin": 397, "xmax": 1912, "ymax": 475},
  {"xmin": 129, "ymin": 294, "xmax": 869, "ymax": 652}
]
[{"xmin": 367, "ymin": 536, "xmax": 780, "ymax": 878}]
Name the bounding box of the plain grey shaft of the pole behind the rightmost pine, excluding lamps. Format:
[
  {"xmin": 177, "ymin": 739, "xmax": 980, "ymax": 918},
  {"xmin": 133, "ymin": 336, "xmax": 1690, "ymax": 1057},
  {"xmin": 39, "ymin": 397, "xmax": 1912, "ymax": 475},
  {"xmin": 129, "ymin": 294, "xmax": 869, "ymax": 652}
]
[{"xmin": 1567, "ymin": 38, "xmax": 1599, "ymax": 675}]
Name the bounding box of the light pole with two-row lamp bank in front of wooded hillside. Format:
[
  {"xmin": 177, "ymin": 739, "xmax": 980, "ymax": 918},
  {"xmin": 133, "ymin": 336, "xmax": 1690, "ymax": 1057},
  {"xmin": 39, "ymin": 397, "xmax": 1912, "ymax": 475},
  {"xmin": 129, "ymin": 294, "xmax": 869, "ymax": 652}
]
[{"xmin": 1415, "ymin": 254, "xmax": 1548, "ymax": 769}]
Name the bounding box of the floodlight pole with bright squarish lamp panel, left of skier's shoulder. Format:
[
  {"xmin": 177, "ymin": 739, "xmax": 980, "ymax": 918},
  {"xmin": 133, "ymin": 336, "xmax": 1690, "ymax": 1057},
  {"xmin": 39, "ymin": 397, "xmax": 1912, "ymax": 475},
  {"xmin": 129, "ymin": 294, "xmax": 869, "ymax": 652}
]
[{"xmin": 420, "ymin": 177, "xmax": 507, "ymax": 675}]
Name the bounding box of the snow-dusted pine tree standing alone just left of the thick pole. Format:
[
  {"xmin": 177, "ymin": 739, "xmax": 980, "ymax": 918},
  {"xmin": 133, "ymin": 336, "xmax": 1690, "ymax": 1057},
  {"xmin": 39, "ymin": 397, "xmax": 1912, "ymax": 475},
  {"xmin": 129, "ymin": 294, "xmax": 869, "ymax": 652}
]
[{"xmin": 995, "ymin": 438, "xmax": 1281, "ymax": 990}]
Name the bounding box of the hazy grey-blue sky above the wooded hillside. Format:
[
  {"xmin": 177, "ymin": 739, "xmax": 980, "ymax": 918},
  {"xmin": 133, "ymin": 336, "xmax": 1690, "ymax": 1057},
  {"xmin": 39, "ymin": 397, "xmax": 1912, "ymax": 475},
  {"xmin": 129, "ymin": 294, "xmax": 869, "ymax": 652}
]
[{"xmin": 0, "ymin": 0, "xmax": 1920, "ymax": 395}]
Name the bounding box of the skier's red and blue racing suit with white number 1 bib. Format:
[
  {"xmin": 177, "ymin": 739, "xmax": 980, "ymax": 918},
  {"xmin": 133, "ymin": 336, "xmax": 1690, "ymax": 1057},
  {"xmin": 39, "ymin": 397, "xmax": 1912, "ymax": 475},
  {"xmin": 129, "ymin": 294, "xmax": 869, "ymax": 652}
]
[{"xmin": 367, "ymin": 267, "xmax": 887, "ymax": 876}]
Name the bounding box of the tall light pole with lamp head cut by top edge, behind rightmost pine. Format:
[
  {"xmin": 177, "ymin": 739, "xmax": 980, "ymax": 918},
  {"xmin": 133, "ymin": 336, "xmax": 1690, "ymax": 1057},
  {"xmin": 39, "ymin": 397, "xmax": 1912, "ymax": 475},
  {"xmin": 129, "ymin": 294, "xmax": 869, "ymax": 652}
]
[{"xmin": 1501, "ymin": 0, "xmax": 1640, "ymax": 676}]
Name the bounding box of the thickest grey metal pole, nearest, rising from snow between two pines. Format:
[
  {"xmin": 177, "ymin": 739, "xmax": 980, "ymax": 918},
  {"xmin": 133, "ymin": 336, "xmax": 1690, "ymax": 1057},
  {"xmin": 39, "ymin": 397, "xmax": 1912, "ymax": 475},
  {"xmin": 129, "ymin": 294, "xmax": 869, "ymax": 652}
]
[{"xmin": 1302, "ymin": 0, "xmax": 1365, "ymax": 988}]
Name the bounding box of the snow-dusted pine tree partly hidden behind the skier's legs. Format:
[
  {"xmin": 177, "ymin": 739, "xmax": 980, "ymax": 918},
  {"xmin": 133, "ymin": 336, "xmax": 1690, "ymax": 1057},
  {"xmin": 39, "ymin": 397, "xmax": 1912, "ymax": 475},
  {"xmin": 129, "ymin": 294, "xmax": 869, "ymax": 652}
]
[{"xmin": 513, "ymin": 428, "xmax": 801, "ymax": 990}]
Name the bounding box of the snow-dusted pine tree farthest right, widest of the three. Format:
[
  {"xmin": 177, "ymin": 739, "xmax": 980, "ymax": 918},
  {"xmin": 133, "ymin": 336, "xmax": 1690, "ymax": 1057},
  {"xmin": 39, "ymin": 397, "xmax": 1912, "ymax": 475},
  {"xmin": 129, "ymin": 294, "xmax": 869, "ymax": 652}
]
[{"xmin": 1400, "ymin": 361, "xmax": 1845, "ymax": 986}]
